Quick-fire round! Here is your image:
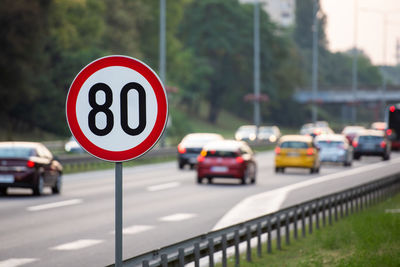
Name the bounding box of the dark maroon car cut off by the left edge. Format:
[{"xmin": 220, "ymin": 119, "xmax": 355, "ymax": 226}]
[{"xmin": 0, "ymin": 142, "xmax": 63, "ymax": 195}]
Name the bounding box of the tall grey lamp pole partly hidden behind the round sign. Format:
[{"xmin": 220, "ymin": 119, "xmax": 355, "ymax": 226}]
[{"xmin": 159, "ymin": 0, "xmax": 167, "ymax": 147}]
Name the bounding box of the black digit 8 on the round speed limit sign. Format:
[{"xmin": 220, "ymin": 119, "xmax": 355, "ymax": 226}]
[{"xmin": 88, "ymin": 83, "xmax": 114, "ymax": 136}]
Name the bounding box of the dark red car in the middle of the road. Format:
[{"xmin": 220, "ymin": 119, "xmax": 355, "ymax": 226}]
[{"xmin": 197, "ymin": 140, "xmax": 257, "ymax": 184}]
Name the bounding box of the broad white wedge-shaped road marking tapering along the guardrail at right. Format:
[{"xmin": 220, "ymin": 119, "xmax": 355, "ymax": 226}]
[{"xmin": 212, "ymin": 158, "xmax": 400, "ymax": 230}]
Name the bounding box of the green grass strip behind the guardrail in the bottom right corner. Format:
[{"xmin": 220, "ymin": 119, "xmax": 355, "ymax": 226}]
[{"xmin": 225, "ymin": 194, "xmax": 400, "ymax": 267}]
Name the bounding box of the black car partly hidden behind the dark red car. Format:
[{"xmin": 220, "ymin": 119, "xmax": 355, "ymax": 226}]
[{"xmin": 178, "ymin": 133, "xmax": 224, "ymax": 169}]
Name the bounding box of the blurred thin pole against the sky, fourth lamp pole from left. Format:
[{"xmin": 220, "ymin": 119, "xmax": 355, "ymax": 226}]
[{"xmin": 351, "ymin": 0, "xmax": 358, "ymax": 124}]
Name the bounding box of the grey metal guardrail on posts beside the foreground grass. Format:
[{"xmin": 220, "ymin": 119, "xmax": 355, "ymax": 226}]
[{"xmin": 109, "ymin": 174, "xmax": 400, "ymax": 267}]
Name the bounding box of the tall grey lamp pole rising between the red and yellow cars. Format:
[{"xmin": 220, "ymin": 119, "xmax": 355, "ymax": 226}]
[{"xmin": 254, "ymin": 0, "xmax": 261, "ymax": 132}]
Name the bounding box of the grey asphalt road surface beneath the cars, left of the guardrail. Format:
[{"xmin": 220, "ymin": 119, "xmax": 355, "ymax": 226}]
[{"xmin": 1, "ymin": 153, "xmax": 382, "ymax": 266}]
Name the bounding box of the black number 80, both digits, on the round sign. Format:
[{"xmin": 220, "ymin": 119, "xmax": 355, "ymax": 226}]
[{"xmin": 88, "ymin": 82, "xmax": 146, "ymax": 136}]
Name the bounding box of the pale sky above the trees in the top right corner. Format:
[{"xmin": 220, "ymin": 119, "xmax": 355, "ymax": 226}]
[{"xmin": 321, "ymin": 0, "xmax": 400, "ymax": 65}]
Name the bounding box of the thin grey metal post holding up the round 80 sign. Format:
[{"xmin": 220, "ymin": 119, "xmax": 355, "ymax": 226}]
[{"xmin": 115, "ymin": 162, "xmax": 123, "ymax": 267}]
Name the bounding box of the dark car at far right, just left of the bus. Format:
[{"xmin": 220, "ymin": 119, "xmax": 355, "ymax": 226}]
[{"xmin": 353, "ymin": 130, "xmax": 391, "ymax": 160}]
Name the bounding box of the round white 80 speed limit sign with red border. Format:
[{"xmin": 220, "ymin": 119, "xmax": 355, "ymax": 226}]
[{"xmin": 66, "ymin": 56, "xmax": 168, "ymax": 162}]
